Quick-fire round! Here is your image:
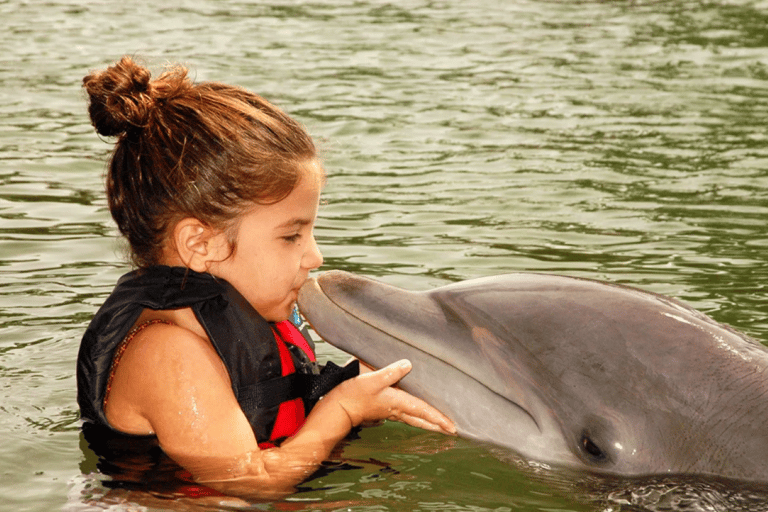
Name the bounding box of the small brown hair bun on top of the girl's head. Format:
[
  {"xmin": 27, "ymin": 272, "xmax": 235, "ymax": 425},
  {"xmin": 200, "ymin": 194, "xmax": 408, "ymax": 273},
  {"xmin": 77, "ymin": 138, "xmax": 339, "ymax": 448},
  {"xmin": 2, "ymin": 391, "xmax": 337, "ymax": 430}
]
[{"xmin": 83, "ymin": 57, "xmax": 155, "ymax": 136}]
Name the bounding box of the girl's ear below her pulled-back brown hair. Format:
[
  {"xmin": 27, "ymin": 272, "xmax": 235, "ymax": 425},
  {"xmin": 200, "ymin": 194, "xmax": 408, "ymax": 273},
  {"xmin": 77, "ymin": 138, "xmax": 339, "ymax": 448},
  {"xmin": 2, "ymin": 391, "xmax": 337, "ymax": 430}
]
[{"xmin": 173, "ymin": 217, "xmax": 229, "ymax": 272}]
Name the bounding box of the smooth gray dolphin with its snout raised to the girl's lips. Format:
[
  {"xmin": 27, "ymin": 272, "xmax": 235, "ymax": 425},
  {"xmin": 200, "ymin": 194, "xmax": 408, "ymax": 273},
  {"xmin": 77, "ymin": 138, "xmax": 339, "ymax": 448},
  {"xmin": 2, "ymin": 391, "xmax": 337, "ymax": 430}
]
[{"xmin": 299, "ymin": 271, "xmax": 768, "ymax": 482}]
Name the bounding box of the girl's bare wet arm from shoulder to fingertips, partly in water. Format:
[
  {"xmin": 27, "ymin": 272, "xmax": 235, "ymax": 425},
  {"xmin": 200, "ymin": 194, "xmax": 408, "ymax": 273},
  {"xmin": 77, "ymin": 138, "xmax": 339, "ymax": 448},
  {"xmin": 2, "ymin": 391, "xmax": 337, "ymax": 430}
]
[{"xmin": 107, "ymin": 324, "xmax": 455, "ymax": 499}]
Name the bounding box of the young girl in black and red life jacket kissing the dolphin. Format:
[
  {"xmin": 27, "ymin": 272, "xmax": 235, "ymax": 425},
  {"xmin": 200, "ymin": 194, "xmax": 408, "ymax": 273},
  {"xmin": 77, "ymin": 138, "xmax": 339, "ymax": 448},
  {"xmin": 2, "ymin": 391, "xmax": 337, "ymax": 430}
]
[{"xmin": 78, "ymin": 57, "xmax": 454, "ymax": 498}]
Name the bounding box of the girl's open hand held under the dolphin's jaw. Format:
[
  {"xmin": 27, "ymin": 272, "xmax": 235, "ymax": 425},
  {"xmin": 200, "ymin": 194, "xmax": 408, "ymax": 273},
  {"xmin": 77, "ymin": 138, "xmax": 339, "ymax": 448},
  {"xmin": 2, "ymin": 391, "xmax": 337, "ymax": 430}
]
[{"xmin": 326, "ymin": 359, "xmax": 456, "ymax": 435}]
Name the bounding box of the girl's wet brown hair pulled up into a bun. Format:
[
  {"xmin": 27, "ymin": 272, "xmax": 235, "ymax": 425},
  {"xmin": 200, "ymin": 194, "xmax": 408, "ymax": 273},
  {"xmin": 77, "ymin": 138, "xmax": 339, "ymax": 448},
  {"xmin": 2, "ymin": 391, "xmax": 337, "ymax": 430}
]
[{"xmin": 83, "ymin": 57, "xmax": 317, "ymax": 268}]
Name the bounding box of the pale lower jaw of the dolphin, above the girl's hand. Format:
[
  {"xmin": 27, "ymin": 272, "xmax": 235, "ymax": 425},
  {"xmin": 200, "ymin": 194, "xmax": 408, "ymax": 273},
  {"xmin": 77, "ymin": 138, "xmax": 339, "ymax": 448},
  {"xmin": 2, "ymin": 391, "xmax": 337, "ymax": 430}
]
[{"xmin": 299, "ymin": 279, "xmax": 577, "ymax": 464}]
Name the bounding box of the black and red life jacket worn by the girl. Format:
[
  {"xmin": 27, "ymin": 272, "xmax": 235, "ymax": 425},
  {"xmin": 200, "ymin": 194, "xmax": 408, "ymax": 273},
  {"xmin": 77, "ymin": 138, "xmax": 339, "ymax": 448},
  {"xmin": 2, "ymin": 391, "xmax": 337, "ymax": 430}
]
[{"xmin": 77, "ymin": 266, "xmax": 358, "ymax": 448}]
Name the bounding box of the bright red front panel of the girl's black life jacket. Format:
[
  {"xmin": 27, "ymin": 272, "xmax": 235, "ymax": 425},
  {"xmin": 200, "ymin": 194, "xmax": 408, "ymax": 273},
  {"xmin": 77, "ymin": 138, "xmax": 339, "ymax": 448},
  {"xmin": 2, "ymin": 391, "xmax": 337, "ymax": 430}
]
[{"xmin": 259, "ymin": 320, "xmax": 316, "ymax": 449}]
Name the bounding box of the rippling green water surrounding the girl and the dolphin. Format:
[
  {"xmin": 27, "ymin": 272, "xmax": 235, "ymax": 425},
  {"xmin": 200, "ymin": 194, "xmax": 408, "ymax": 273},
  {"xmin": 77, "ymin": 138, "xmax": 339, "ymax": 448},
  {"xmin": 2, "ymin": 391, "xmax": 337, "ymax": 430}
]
[{"xmin": 0, "ymin": 0, "xmax": 768, "ymax": 512}]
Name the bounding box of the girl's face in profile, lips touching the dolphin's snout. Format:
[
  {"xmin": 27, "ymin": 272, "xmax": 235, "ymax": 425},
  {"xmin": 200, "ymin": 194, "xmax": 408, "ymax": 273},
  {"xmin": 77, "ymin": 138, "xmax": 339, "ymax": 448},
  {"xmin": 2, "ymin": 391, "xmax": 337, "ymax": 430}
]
[{"xmin": 209, "ymin": 160, "xmax": 324, "ymax": 322}]
